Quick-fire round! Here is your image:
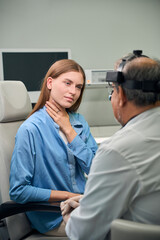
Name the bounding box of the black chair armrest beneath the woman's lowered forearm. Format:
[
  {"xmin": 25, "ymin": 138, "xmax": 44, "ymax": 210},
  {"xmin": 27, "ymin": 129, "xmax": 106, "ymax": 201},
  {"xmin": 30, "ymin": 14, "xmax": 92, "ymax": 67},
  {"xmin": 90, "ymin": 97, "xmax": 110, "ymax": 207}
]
[{"xmin": 0, "ymin": 201, "xmax": 60, "ymax": 219}]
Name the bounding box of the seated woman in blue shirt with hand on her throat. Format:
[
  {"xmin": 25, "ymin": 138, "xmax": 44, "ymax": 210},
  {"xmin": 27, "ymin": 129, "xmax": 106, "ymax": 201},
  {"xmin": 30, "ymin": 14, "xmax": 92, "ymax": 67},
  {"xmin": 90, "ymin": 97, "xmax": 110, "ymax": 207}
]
[{"xmin": 10, "ymin": 60, "xmax": 97, "ymax": 236}]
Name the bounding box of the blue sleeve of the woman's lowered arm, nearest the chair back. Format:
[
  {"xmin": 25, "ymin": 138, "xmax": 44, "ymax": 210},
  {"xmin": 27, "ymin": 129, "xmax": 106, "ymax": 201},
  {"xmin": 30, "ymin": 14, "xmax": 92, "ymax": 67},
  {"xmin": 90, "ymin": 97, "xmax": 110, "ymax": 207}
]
[{"xmin": 9, "ymin": 127, "xmax": 51, "ymax": 203}]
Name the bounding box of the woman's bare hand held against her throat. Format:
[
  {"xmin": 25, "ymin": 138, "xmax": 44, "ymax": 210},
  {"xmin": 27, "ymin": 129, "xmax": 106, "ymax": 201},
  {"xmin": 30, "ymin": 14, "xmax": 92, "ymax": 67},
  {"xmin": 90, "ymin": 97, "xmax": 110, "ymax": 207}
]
[{"xmin": 45, "ymin": 101, "xmax": 77, "ymax": 143}]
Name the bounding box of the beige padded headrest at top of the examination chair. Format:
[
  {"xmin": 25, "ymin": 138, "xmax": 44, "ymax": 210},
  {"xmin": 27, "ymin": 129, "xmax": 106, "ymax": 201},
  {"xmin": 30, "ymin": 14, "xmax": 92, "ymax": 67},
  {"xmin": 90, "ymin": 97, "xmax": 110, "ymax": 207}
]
[{"xmin": 0, "ymin": 81, "xmax": 32, "ymax": 122}]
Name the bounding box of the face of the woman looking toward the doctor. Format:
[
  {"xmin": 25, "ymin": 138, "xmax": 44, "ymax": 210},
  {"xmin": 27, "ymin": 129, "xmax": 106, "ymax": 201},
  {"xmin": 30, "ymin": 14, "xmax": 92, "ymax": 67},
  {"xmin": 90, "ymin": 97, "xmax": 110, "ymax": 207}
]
[{"xmin": 47, "ymin": 71, "xmax": 84, "ymax": 108}]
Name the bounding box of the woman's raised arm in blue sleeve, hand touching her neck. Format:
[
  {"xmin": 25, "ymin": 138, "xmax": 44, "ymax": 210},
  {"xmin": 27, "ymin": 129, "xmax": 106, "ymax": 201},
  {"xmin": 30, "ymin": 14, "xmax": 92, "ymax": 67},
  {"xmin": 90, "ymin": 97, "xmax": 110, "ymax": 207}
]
[{"xmin": 46, "ymin": 102, "xmax": 98, "ymax": 174}]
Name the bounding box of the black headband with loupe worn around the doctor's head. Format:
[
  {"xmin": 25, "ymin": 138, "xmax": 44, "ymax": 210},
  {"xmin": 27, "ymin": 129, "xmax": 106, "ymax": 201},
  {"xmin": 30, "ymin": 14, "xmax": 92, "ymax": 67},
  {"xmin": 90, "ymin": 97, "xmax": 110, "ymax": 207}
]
[{"xmin": 106, "ymin": 50, "xmax": 160, "ymax": 93}]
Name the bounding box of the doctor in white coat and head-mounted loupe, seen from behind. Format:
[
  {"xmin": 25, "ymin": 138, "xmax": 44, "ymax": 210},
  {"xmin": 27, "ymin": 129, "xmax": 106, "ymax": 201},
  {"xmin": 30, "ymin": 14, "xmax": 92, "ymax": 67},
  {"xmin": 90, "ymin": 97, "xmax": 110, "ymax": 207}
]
[{"xmin": 61, "ymin": 51, "xmax": 160, "ymax": 240}]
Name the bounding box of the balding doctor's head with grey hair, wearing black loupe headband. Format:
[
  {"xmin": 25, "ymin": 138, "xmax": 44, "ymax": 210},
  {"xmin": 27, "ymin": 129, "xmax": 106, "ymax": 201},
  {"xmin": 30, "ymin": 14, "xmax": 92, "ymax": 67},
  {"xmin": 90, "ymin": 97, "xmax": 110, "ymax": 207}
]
[{"xmin": 107, "ymin": 50, "xmax": 160, "ymax": 125}]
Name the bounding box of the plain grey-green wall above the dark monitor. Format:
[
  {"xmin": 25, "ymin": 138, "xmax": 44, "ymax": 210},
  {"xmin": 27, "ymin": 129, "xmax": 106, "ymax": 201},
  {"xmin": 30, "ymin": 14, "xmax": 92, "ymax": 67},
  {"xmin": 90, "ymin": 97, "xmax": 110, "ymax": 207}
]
[{"xmin": 0, "ymin": 0, "xmax": 160, "ymax": 69}]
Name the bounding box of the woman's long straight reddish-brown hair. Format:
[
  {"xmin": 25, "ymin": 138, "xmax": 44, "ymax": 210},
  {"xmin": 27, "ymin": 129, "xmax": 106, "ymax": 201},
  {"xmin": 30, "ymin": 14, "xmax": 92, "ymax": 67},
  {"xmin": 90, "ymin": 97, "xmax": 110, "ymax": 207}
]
[{"xmin": 29, "ymin": 59, "xmax": 86, "ymax": 116}]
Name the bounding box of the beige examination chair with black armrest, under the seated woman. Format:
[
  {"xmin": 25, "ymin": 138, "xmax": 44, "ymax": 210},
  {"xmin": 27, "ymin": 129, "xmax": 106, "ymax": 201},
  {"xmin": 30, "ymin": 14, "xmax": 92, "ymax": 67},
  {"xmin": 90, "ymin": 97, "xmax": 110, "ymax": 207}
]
[{"xmin": 0, "ymin": 81, "xmax": 68, "ymax": 240}]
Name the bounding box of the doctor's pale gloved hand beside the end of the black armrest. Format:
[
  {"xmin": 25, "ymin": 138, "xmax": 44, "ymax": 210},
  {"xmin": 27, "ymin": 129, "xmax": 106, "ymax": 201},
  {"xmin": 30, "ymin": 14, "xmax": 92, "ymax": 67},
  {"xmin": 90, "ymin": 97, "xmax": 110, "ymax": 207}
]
[{"xmin": 60, "ymin": 195, "xmax": 83, "ymax": 223}]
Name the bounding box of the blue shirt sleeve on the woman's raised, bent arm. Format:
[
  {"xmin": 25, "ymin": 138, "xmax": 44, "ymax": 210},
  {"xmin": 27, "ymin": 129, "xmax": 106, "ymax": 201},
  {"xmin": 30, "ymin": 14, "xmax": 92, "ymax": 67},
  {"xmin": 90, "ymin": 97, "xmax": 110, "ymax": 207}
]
[{"xmin": 68, "ymin": 114, "xmax": 98, "ymax": 174}]
